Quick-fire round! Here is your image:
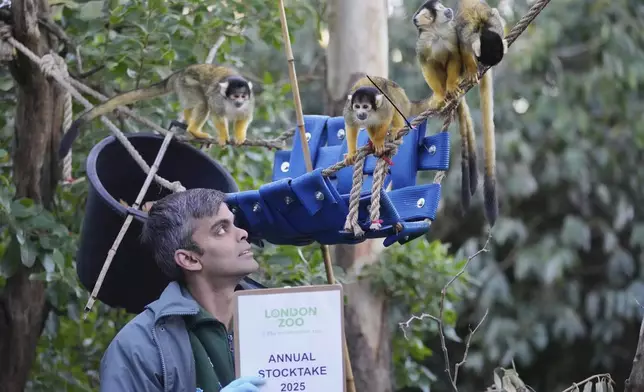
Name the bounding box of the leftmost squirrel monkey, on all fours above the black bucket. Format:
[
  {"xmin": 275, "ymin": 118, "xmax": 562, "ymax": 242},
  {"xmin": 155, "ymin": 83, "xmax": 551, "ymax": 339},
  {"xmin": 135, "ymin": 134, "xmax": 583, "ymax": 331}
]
[{"xmin": 59, "ymin": 64, "xmax": 255, "ymax": 157}]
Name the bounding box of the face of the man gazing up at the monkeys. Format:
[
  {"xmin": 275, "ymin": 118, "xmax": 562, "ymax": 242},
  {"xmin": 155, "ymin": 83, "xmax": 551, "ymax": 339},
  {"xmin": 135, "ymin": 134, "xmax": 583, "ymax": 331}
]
[{"xmin": 181, "ymin": 203, "xmax": 259, "ymax": 280}]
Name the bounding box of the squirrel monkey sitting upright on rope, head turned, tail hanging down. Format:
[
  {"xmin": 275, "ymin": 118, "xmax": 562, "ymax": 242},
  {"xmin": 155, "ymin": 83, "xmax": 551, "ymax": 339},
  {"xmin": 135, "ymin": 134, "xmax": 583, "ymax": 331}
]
[{"xmin": 412, "ymin": 0, "xmax": 478, "ymax": 211}]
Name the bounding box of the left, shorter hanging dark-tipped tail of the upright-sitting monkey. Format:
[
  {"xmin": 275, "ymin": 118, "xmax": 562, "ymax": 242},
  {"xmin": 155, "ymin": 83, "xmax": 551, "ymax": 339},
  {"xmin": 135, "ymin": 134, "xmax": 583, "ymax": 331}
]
[{"xmin": 456, "ymin": 97, "xmax": 478, "ymax": 213}]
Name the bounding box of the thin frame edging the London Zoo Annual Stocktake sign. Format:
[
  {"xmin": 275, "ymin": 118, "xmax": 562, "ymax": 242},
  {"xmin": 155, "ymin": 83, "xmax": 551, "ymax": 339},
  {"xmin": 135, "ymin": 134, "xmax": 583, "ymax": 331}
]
[{"xmin": 233, "ymin": 283, "xmax": 347, "ymax": 392}]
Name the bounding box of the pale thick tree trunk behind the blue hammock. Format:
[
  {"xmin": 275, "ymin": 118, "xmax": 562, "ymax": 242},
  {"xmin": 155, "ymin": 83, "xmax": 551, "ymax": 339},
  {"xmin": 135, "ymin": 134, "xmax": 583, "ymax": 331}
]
[{"xmin": 326, "ymin": 0, "xmax": 392, "ymax": 392}]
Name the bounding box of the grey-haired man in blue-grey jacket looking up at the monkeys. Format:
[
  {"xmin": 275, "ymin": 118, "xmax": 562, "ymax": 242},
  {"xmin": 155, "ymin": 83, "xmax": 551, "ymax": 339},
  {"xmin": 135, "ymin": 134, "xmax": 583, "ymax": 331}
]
[{"xmin": 100, "ymin": 189, "xmax": 264, "ymax": 392}]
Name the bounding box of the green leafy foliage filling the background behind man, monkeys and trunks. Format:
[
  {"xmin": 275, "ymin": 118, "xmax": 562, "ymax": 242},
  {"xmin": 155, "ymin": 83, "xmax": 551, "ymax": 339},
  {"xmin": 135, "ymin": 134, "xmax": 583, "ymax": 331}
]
[{"xmin": 0, "ymin": 0, "xmax": 644, "ymax": 391}]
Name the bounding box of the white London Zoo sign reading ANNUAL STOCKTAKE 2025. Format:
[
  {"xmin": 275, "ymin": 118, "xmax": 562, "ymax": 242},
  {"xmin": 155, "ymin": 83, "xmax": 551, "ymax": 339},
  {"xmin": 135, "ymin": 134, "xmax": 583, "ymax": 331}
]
[{"xmin": 233, "ymin": 284, "xmax": 346, "ymax": 392}]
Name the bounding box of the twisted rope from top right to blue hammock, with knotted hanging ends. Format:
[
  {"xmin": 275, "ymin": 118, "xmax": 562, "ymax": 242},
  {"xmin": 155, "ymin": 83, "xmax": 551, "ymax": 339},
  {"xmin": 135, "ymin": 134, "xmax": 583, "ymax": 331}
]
[{"xmin": 334, "ymin": 0, "xmax": 550, "ymax": 236}]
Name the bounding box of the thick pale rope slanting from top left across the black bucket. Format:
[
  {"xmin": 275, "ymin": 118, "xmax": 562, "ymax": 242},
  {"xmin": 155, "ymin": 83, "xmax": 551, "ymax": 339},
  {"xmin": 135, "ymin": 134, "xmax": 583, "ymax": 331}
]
[{"xmin": 0, "ymin": 22, "xmax": 185, "ymax": 192}]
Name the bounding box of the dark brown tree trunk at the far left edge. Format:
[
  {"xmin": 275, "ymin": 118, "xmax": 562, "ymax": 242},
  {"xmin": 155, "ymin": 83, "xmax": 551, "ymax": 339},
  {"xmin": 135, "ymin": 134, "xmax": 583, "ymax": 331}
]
[{"xmin": 0, "ymin": 0, "xmax": 63, "ymax": 392}]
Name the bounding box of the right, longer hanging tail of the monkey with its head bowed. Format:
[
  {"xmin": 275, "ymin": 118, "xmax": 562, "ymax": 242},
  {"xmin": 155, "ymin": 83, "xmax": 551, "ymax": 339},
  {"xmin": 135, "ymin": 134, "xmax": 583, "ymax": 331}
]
[{"xmin": 480, "ymin": 69, "xmax": 499, "ymax": 226}]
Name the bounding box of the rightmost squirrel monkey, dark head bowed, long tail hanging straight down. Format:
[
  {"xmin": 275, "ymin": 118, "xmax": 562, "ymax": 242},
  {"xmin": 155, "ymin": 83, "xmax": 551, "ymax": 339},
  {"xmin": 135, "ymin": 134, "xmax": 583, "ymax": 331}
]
[{"xmin": 456, "ymin": 0, "xmax": 508, "ymax": 226}]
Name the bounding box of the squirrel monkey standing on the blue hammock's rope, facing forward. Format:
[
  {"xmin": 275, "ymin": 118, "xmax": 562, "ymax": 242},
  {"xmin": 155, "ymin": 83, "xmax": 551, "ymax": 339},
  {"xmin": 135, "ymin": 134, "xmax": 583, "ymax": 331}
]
[{"xmin": 342, "ymin": 76, "xmax": 411, "ymax": 165}]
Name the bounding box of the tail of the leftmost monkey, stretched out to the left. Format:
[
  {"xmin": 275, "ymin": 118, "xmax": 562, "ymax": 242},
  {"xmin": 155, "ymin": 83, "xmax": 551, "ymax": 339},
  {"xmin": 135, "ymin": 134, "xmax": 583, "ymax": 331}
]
[{"xmin": 58, "ymin": 78, "xmax": 174, "ymax": 159}]
